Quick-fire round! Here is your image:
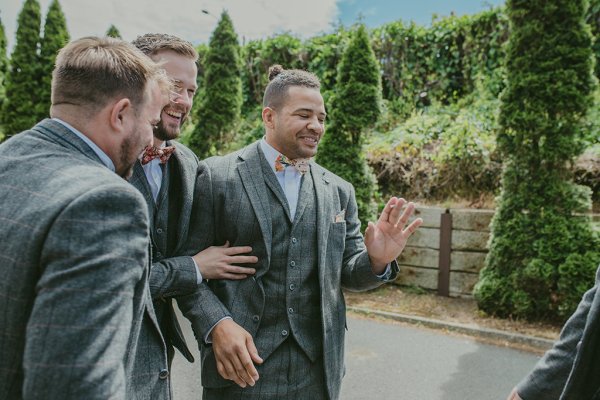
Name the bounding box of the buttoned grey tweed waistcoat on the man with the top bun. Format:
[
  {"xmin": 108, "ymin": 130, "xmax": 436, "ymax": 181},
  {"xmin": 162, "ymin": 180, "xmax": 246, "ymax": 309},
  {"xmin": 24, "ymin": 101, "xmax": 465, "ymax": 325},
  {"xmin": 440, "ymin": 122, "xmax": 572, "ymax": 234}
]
[{"xmin": 255, "ymin": 162, "xmax": 322, "ymax": 361}]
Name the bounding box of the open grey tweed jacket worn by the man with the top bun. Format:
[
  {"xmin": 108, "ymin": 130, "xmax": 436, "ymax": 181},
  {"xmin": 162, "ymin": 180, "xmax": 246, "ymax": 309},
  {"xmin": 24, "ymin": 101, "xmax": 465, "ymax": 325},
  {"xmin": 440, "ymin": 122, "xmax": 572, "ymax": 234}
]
[{"xmin": 183, "ymin": 142, "xmax": 398, "ymax": 399}]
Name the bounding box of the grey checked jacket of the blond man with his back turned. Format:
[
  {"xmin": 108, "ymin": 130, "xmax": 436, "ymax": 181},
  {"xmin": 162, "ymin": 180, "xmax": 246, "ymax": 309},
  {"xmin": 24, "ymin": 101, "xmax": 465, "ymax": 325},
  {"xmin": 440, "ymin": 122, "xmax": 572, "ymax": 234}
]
[{"xmin": 0, "ymin": 120, "xmax": 169, "ymax": 399}]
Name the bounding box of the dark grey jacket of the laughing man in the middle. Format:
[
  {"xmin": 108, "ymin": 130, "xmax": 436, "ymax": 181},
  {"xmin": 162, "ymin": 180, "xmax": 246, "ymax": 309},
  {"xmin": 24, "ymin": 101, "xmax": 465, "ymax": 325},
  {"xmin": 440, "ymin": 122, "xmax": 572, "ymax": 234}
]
[{"xmin": 129, "ymin": 142, "xmax": 204, "ymax": 362}]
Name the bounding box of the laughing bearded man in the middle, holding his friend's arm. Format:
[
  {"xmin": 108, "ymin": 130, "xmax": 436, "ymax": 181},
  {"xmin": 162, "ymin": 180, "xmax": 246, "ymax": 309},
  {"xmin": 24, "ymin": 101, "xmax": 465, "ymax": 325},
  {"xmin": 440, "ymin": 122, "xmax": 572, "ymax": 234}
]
[{"xmin": 130, "ymin": 34, "xmax": 256, "ymax": 362}]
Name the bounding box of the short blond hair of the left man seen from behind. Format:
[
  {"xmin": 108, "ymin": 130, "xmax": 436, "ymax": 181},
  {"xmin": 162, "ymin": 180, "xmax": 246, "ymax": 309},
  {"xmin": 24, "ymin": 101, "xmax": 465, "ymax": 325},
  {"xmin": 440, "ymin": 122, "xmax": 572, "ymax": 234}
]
[{"xmin": 52, "ymin": 37, "xmax": 170, "ymax": 111}]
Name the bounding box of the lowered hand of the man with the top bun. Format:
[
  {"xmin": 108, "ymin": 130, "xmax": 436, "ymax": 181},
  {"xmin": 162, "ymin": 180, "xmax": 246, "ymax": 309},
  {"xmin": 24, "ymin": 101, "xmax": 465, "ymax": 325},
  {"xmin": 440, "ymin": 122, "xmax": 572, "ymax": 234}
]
[{"xmin": 211, "ymin": 318, "xmax": 263, "ymax": 387}]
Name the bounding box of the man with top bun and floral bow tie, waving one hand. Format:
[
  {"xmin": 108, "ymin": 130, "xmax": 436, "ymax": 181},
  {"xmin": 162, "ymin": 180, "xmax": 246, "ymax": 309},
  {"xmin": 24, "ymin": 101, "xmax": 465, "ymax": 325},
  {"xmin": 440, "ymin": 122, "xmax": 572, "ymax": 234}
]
[{"xmin": 190, "ymin": 66, "xmax": 421, "ymax": 400}]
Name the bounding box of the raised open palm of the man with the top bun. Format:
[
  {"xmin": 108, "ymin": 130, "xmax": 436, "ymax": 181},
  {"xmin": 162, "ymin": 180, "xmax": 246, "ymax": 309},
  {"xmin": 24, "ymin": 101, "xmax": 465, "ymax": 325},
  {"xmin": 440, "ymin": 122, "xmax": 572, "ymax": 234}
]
[{"xmin": 365, "ymin": 197, "xmax": 423, "ymax": 274}]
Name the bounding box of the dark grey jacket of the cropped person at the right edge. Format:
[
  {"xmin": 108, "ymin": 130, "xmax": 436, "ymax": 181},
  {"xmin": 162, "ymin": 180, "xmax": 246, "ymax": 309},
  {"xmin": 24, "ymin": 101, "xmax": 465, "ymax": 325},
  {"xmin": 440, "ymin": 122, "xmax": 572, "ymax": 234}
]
[{"xmin": 517, "ymin": 268, "xmax": 600, "ymax": 400}]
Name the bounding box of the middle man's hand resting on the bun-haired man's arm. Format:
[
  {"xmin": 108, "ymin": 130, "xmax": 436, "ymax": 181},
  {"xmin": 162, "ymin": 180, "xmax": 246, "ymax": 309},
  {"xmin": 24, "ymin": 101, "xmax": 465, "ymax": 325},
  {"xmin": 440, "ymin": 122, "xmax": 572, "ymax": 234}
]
[{"xmin": 192, "ymin": 242, "xmax": 258, "ymax": 279}]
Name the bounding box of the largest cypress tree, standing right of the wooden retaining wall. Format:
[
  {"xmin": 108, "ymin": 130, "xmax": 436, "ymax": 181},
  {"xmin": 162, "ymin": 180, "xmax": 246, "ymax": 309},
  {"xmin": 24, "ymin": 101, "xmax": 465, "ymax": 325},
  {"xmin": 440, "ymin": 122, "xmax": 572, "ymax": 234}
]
[{"xmin": 475, "ymin": 0, "xmax": 600, "ymax": 319}]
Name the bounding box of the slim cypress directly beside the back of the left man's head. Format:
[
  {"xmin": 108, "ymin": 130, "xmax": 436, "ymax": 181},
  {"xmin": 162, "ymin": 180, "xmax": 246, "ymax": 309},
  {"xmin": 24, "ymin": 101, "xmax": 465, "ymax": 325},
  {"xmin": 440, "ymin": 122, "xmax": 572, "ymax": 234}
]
[{"xmin": 37, "ymin": 0, "xmax": 69, "ymax": 120}]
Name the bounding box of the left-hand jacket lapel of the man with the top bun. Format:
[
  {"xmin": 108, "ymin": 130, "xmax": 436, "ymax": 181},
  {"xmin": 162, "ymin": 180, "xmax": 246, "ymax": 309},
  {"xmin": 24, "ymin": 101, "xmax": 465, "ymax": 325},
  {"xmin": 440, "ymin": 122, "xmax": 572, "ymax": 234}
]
[{"xmin": 237, "ymin": 142, "xmax": 273, "ymax": 272}]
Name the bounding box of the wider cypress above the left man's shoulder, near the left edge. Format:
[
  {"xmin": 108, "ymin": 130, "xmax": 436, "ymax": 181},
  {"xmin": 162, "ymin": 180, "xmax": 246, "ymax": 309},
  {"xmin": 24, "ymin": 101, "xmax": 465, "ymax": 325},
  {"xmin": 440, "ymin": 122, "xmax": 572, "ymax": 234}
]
[{"xmin": 1, "ymin": 0, "xmax": 41, "ymax": 137}]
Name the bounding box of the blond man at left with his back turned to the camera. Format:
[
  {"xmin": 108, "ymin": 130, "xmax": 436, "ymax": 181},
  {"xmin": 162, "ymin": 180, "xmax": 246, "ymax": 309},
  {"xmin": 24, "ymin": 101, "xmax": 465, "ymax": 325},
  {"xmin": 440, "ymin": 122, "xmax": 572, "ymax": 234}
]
[{"xmin": 0, "ymin": 38, "xmax": 170, "ymax": 399}]
